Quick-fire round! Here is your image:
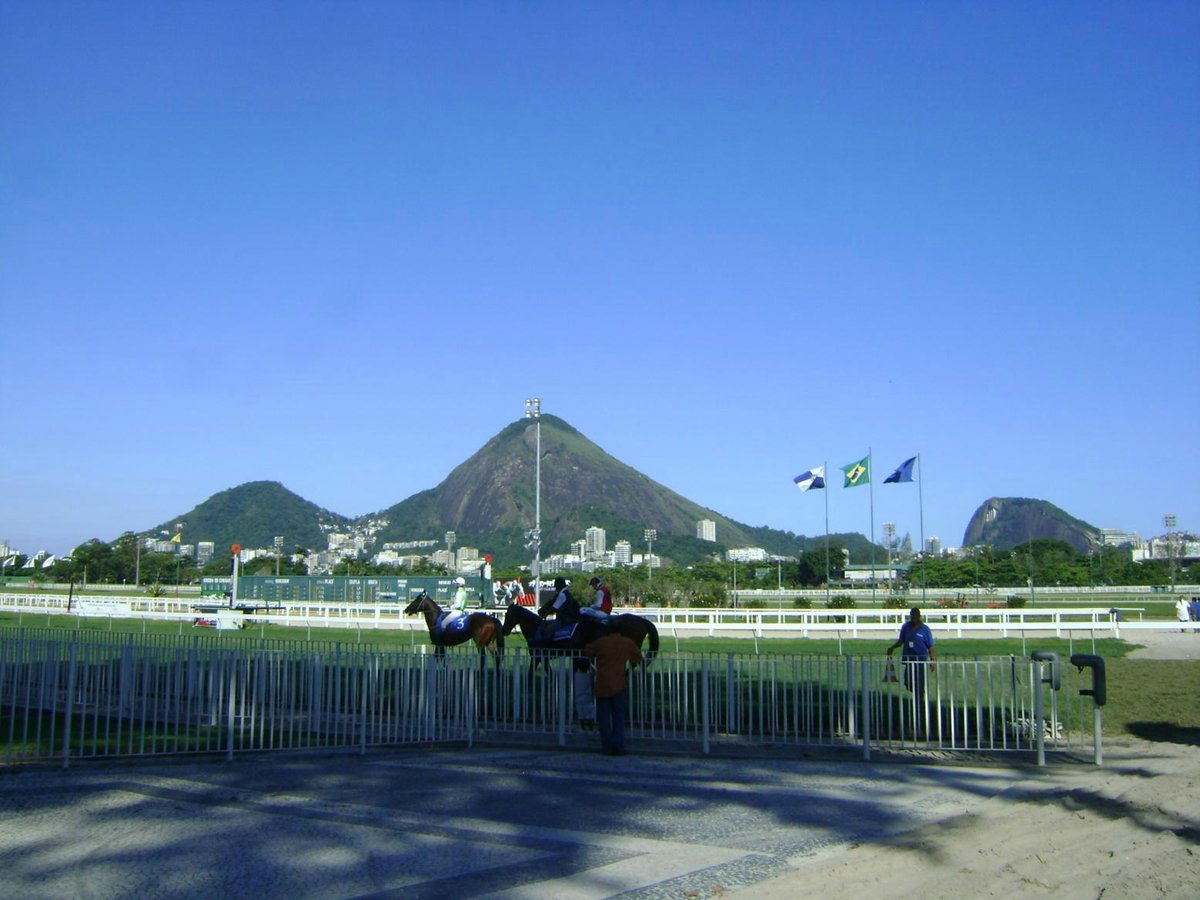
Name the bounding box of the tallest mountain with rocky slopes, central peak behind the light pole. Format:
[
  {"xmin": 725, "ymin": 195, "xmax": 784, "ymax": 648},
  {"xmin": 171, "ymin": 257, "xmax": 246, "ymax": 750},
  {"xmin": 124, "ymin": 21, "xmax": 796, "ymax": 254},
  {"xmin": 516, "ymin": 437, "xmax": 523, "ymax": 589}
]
[{"xmin": 364, "ymin": 415, "xmax": 823, "ymax": 563}]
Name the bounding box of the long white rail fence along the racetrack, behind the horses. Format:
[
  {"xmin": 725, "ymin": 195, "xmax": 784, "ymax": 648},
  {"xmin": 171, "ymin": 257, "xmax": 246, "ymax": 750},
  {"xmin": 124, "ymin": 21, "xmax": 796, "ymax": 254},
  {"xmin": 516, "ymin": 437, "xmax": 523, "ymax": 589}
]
[{"xmin": 0, "ymin": 594, "xmax": 1185, "ymax": 638}]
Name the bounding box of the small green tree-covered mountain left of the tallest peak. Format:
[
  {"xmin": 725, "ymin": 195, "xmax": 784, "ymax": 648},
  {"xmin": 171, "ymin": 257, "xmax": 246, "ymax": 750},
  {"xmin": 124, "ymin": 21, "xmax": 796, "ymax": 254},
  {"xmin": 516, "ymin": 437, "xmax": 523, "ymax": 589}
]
[{"xmin": 145, "ymin": 481, "xmax": 350, "ymax": 552}]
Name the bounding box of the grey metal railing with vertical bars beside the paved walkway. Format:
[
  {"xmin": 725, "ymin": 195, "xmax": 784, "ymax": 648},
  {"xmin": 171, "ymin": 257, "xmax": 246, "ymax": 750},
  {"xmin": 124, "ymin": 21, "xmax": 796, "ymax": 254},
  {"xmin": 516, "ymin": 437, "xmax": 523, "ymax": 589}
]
[{"xmin": 0, "ymin": 630, "xmax": 1098, "ymax": 766}]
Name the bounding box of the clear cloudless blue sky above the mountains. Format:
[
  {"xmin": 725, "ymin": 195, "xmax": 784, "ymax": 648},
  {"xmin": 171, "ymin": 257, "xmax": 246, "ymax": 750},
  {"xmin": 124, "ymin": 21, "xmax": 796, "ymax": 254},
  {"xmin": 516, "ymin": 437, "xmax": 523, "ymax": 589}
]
[{"xmin": 0, "ymin": 0, "xmax": 1200, "ymax": 553}]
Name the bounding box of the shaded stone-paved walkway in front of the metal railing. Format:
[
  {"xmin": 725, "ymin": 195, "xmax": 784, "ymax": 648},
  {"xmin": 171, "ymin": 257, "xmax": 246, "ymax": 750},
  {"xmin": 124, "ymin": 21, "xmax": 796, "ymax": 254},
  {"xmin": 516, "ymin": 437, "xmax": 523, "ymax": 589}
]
[{"xmin": 0, "ymin": 734, "xmax": 1180, "ymax": 900}]
